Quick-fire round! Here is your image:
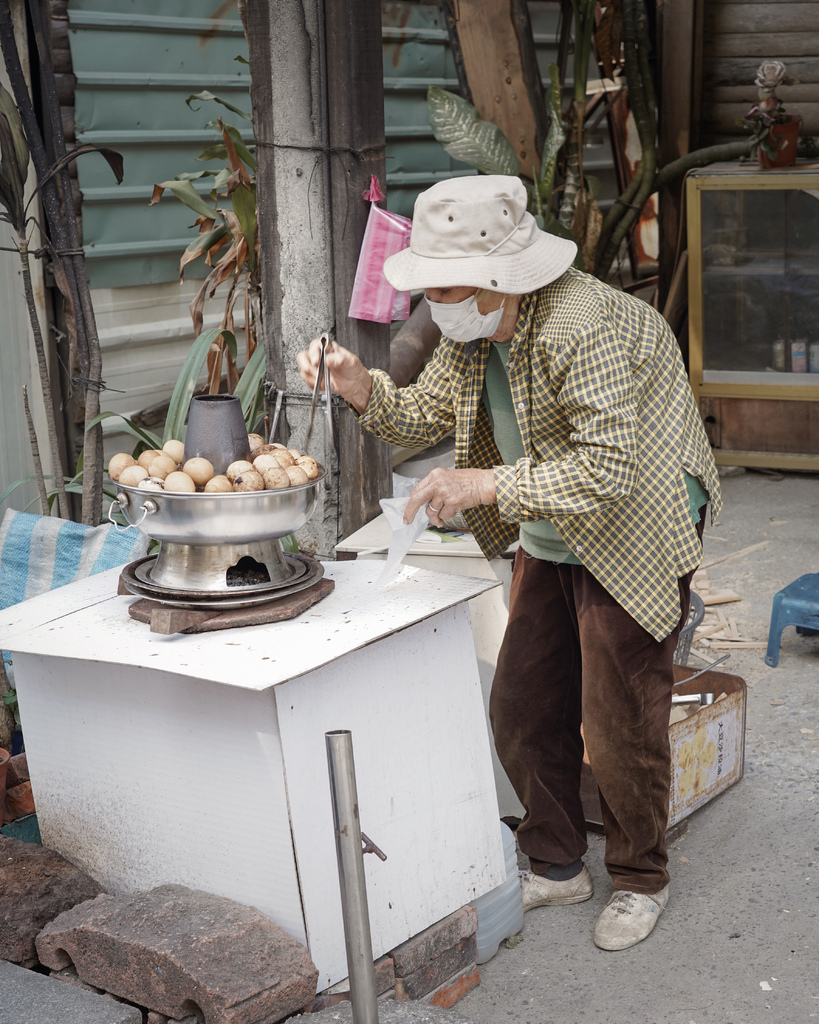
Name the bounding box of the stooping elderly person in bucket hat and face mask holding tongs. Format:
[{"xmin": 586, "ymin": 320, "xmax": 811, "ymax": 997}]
[{"xmin": 298, "ymin": 175, "xmax": 721, "ymax": 949}]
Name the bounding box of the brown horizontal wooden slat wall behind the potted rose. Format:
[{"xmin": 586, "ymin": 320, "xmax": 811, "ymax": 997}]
[{"xmin": 699, "ymin": 0, "xmax": 819, "ymax": 145}]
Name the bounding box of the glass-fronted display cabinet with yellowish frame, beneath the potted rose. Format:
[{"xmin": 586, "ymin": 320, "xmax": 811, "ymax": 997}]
[{"xmin": 686, "ymin": 164, "xmax": 819, "ymax": 470}]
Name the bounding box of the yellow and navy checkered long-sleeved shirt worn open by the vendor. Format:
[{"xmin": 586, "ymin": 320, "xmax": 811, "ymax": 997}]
[{"xmin": 359, "ymin": 269, "xmax": 722, "ymax": 640}]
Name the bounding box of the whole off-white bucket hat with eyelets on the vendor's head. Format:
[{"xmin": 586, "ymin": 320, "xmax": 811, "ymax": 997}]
[{"xmin": 384, "ymin": 174, "xmax": 577, "ymax": 295}]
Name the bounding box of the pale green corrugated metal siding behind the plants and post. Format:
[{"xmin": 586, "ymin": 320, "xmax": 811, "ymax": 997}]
[{"xmin": 69, "ymin": 0, "xmax": 615, "ymax": 288}]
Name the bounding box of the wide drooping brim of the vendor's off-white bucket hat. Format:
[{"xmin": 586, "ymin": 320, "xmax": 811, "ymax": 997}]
[{"xmin": 384, "ymin": 231, "xmax": 577, "ymax": 295}]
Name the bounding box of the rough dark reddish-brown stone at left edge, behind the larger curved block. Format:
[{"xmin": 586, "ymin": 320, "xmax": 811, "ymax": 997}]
[{"xmin": 0, "ymin": 836, "xmax": 102, "ymax": 967}]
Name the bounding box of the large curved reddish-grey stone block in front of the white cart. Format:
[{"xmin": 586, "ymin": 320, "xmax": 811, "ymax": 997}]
[{"xmin": 37, "ymin": 885, "xmax": 318, "ymax": 1024}]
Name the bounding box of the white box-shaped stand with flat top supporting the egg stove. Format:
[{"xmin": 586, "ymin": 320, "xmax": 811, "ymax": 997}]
[{"xmin": 0, "ymin": 561, "xmax": 505, "ymax": 989}]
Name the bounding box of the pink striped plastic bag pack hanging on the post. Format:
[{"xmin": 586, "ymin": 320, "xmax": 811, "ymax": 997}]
[{"xmin": 348, "ymin": 175, "xmax": 413, "ymax": 324}]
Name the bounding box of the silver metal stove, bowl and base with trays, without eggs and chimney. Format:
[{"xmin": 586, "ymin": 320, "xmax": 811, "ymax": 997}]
[{"xmin": 109, "ymin": 469, "xmax": 327, "ymax": 610}]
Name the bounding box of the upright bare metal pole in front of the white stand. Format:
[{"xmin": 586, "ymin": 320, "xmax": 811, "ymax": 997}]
[{"xmin": 325, "ymin": 729, "xmax": 378, "ymax": 1024}]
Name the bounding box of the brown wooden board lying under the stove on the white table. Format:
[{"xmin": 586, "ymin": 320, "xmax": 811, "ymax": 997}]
[{"xmin": 128, "ymin": 578, "xmax": 336, "ymax": 636}]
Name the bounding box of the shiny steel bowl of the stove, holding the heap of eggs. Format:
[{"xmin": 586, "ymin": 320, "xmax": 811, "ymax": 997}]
[{"xmin": 115, "ymin": 469, "xmax": 327, "ymax": 545}]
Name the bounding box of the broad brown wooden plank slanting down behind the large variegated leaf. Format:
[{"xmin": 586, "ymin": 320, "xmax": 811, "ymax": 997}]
[{"xmin": 438, "ymin": 0, "xmax": 547, "ymax": 178}]
